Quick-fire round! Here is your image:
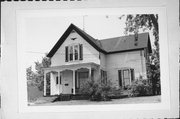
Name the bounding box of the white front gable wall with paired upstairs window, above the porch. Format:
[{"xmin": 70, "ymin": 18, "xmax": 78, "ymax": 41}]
[{"xmin": 48, "ymin": 26, "xmax": 100, "ymax": 66}]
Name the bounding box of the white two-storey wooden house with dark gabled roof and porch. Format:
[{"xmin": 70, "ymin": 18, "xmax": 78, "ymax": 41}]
[{"xmin": 44, "ymin": 24, "xmax": 152, "ymax": 96}]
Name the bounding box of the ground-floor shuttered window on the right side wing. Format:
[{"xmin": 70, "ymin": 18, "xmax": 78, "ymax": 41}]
[{"xmin": 118, "ymin": 68, "xmax": 134, "ymax": 88}]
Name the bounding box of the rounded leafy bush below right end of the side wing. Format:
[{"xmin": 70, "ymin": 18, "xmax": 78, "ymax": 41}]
[{"xmin": 128, "ymin": 79, "xmax": 152, "ymax": 97}]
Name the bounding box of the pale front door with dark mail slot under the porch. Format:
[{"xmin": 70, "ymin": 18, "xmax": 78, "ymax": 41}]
[{"xmin": 61, "ymin": 71, "xmax": 73, "ymax": 94}]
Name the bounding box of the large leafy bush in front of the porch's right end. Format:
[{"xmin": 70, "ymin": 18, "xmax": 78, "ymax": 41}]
[{"xmin": 80, "ymin": 79, "xmax": 113, "ymax": 101}]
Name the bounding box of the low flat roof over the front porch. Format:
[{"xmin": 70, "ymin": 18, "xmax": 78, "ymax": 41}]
[{"xmin": 43, "ymin": 62, "xmax": 100, "ymax": 71}]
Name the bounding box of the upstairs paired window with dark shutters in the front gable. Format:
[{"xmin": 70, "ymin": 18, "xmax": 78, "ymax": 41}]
[{"xmin": 65, "ymin": 44, "xmax": 83, "ymax": 62}]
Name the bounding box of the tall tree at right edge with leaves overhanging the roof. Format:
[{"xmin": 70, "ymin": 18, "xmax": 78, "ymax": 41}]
[{"xmin": 124, "ymin": 14, "xmax": 160, "ymax": 94}]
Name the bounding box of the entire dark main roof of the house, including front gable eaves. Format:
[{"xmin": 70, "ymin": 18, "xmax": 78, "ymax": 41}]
[{"xmin": 47, "ymin": 24, "xmax": 152, "ymax": 57}]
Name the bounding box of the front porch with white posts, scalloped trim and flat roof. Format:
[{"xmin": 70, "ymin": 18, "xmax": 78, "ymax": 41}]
[{"xmin": 44, "ymin": 63, "xmax": 100, "ymax": 96}]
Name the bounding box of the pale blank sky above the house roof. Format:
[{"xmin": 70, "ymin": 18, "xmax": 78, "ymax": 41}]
[{"xmin": 25, "ymin": 15, "xmax": 155, "ymax": 67}]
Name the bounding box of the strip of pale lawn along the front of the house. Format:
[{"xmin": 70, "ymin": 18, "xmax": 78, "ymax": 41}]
[{"xmin": 30, "ymin": 96, "xmax": 161, "ymax": 106}]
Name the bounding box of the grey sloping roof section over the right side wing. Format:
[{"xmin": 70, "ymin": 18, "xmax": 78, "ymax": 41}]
[{"xmin": 100, "ymin": 33, "xmax": 151, "ymax": 53}]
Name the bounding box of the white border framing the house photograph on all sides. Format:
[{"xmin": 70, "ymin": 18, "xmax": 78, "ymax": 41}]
[{"xmin": 16, "ymin": 7, "xmax": 170, "ymax": 113}]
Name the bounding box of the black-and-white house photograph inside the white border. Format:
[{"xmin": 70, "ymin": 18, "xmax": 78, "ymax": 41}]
[{"xmin": 25, "ymin": 14, "xmax": 161, "ymax": 106}]
